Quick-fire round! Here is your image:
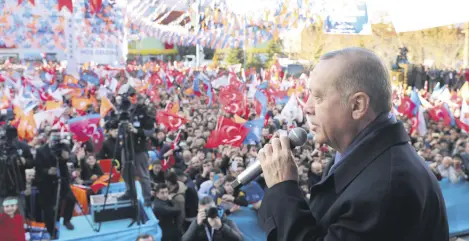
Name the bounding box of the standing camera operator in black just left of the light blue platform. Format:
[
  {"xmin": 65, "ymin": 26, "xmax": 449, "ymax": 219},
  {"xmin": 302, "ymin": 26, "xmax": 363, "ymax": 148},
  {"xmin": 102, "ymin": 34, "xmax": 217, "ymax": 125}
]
[{"xmin": 35, "ymin": 130, "xmax": 75, "ymax": 237}]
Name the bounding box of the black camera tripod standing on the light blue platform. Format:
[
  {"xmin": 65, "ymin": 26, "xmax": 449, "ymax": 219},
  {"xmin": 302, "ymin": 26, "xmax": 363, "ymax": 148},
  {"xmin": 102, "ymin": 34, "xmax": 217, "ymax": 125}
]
[{"xmin": 98, "ymin": 120, "xmax": 145, "ymax": 232}]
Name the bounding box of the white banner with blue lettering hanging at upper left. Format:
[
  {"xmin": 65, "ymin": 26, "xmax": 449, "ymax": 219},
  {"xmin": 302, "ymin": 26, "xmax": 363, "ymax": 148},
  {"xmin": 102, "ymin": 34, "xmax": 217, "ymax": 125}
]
[{"xmin": 67, "ymin": 0, "xmax": 127, "ymax": 65}]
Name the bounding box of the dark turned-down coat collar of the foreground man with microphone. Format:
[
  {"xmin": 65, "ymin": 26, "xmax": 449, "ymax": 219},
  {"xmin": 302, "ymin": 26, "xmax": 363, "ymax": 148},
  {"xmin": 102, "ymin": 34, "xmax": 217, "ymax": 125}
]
[{"xmin": 326, "ymin": 122, "xmax": 410, "ymax": 193}]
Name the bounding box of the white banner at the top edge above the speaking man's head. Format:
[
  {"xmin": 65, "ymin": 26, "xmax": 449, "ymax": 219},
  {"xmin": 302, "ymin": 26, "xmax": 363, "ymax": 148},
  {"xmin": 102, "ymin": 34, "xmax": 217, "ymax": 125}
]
[{"xmin": 323, "ymin": 0, "xmax": 371, "ymax": 35}]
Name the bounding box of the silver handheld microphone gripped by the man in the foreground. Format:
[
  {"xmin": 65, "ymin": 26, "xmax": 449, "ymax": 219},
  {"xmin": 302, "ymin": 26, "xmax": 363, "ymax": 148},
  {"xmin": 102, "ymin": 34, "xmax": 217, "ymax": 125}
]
[{"xmin": 231, "ymin": 127, "xmax": 308, "ymax": 189}]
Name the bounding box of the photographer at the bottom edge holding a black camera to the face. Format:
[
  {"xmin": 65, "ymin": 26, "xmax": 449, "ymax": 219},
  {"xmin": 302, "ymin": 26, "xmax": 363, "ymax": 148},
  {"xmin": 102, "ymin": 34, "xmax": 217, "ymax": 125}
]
[{"xmin": 182, "ymin": 197, "xmax": 244, "ymax": 241}]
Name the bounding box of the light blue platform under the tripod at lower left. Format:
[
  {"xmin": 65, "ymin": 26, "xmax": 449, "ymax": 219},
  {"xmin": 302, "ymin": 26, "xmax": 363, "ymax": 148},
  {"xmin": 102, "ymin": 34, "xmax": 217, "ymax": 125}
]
[{"xmin": 58, "ymin": 182, "xmax": 162, "ymax": 241}]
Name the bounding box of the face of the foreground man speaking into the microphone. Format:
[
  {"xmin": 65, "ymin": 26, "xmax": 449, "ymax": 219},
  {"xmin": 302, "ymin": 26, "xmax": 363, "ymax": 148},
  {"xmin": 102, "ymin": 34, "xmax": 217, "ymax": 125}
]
[{"xmin": 304, "ymin": 59, "xmax": 352, "ymax": 147}]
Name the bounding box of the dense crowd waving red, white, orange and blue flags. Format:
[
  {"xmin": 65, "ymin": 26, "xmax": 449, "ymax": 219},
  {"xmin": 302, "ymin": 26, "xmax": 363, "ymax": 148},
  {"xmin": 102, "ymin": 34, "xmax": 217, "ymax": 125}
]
[{"xmin": 0, "ymin": 55, "xmax": 469, "ymax": 241}]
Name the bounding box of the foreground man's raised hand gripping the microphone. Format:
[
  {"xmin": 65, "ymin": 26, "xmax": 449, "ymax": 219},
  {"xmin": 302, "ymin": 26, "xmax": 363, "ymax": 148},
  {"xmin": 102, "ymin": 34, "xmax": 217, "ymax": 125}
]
[{"xmin": 257, "ymin": 136, "xmax": 298, "ymax": 188}]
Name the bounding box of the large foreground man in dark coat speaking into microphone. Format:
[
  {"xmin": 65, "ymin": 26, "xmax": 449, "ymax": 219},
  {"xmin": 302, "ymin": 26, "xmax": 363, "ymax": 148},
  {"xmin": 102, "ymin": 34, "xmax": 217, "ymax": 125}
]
[{"xmin": 258, "ymin": 48, "xmax": 449, "ymax": 241}]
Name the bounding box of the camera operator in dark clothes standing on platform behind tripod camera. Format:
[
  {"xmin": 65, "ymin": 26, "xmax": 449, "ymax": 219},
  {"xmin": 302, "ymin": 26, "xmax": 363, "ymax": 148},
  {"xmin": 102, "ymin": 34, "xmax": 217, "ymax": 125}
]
[{"xmin": 119, "ymin": 96, "xmax": 155, "ymax": 207}]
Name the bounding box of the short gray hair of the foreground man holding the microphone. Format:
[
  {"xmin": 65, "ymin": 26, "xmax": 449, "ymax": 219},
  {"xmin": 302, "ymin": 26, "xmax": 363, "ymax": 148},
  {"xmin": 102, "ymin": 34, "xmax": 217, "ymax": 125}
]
[{"xmin": 320, "ymin": 47, "xmax": 392, "ymax": 114}]
